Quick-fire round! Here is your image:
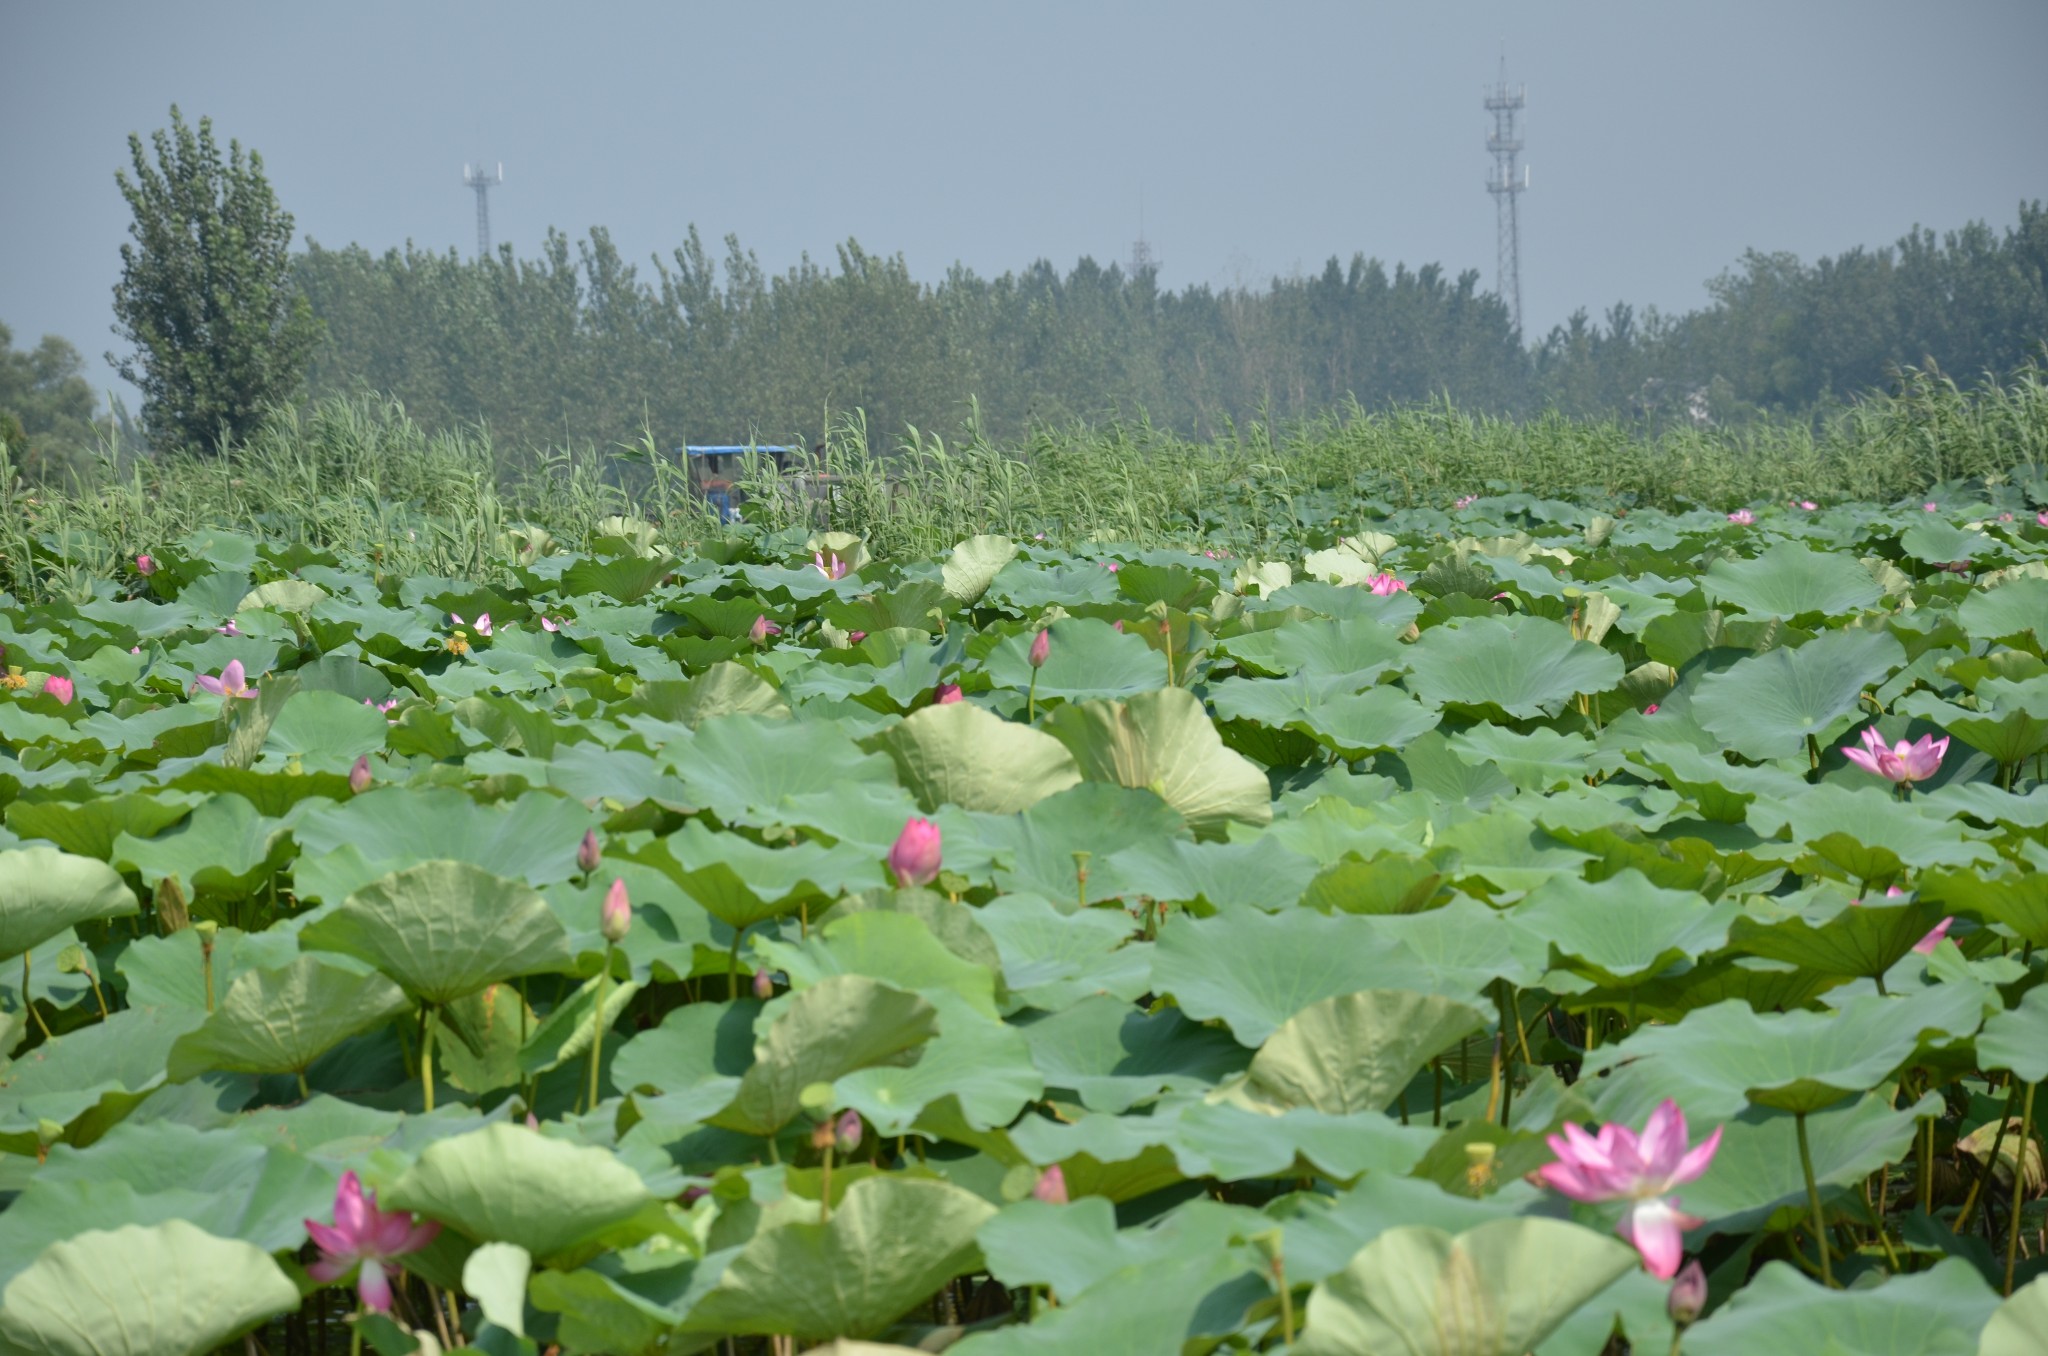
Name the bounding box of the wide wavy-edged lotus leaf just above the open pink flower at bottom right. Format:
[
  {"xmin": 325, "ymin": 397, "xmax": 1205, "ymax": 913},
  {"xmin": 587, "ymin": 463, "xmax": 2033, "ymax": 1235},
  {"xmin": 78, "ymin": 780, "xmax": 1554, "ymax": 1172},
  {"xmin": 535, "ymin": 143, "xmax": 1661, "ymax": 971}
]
[{"xmin": 1585, "ymin": 985, "xmax": 1982, "ymax": 1122}]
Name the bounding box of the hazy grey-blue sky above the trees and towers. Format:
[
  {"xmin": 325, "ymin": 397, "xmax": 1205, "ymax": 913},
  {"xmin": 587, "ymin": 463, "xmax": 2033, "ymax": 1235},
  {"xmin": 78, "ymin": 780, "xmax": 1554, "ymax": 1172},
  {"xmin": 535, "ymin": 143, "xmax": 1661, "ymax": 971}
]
[{"xmin": 0, "ymin": 0, "xmax": 2048, "ymax": 401}]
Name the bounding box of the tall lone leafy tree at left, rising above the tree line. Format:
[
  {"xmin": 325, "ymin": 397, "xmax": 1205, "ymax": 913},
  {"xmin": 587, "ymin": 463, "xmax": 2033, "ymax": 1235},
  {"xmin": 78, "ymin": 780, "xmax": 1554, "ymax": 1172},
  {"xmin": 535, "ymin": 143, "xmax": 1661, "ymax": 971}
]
[{"xmin": 109, "ymin": 107, "xmax": 319, "ymax": 449}]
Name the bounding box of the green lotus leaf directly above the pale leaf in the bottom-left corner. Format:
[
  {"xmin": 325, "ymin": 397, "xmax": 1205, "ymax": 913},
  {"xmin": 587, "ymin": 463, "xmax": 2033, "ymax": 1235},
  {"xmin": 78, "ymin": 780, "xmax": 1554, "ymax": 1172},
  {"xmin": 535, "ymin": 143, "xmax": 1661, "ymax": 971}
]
[{"xmin": 0, "ymin": 1120, "xmax": 336, "ymax": 1286}]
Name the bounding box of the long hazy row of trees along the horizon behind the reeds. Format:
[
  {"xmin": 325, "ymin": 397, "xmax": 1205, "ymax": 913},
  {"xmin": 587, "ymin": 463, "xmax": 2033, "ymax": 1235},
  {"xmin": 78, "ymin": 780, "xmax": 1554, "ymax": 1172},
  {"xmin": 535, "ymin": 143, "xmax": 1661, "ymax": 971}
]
[{"xmin": 297, "ymin": 205, "xmax": 2048, "ymax": 447}]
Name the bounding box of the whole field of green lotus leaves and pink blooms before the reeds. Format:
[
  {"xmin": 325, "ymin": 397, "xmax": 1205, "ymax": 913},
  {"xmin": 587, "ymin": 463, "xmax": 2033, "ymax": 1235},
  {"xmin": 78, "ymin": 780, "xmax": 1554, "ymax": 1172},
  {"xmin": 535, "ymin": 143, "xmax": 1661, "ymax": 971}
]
[{"xmin": 0, "ymin": 483, "xmax": 2048, "ymax": 1356}]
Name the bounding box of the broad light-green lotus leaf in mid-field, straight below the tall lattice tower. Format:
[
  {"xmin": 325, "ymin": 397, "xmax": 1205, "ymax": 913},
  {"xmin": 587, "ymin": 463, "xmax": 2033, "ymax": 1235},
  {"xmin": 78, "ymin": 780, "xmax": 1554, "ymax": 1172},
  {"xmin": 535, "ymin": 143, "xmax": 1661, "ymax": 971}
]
[{"xmin": 1405, "ymin": 617, "xmax": 1624, "ymax": 717}]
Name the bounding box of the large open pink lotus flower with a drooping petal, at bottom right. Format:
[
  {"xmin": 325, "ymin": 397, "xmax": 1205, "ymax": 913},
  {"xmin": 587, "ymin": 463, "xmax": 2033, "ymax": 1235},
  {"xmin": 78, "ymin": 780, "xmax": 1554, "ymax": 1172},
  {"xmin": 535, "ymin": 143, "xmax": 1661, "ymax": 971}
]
[{"xmin": 1536, "ymin": 1098, "xmax": 1720, "ymax": 1280}]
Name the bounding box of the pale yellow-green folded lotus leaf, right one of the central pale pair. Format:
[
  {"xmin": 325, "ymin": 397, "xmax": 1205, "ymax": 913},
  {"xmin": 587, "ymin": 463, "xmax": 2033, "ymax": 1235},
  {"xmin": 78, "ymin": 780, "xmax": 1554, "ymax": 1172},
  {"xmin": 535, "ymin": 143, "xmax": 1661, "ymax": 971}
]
[{"xmin": 1047, "ymin": 692, "xmax": 1272, "ymax": 836}]
